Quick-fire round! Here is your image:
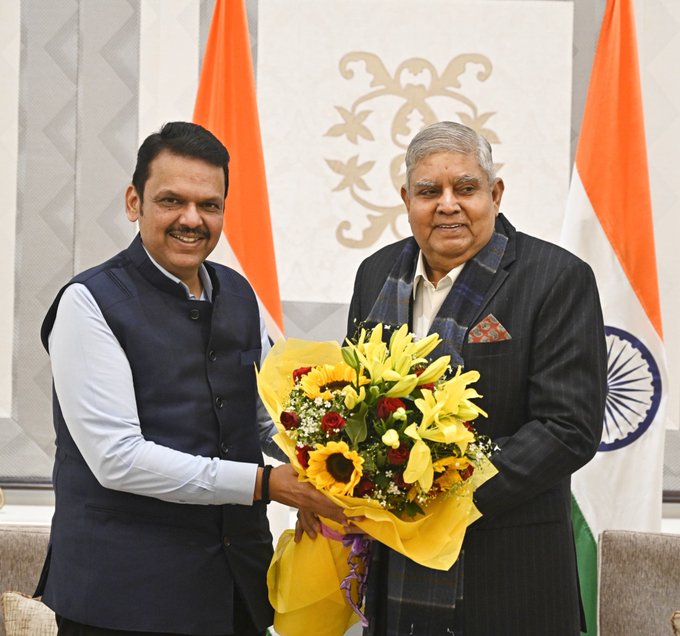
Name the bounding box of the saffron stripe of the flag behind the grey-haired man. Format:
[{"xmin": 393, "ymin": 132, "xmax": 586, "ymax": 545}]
[{"xmin": 576, "ymin": 0, "xmax": 662, "ymax": 337}]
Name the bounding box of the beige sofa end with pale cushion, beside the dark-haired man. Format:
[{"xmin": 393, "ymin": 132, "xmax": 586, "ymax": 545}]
[{"xmin": 0, "ymin": 524, "xmax": 57, "ymax": 636}]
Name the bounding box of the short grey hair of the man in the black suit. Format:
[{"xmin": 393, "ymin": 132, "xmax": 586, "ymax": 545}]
[{"xmin": 406, "ymin": 121, "xmax": 496, "ymax": 188}]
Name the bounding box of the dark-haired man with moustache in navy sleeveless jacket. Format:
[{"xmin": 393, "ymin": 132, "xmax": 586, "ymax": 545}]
[{"xmin": 38, "ymin": 122, "xmax": 344, "ymax": 636}]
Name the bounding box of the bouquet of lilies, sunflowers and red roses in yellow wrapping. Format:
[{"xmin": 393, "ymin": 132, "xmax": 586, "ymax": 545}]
[{"xmin": 258, "ymin": 324, "xmax": 495, "ymax": 636}]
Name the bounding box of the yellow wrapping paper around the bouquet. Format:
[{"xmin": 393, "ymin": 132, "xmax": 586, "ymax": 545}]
[{"xmin": 258, "ymin": 338, "xmax": 497, "ymax": 636}]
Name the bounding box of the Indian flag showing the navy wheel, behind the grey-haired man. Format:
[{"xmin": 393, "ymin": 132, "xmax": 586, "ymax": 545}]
[{"xmin": 561, "ymin": 0, "xmax": 667, "ymax": 636}]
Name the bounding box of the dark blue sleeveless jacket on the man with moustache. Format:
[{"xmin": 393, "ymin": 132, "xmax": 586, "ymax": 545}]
[{"xmin": 37, "ymin": 236, "xmax": 272, "ymax": 635}]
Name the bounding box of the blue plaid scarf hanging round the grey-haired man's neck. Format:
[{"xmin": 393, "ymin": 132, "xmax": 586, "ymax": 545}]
[{"xmin": 364, "ymin": 219, "xmax": 508, "ymax": 636}]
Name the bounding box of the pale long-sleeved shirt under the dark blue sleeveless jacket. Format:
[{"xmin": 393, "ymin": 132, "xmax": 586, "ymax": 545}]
[{"xmin": 49, "ymin": 257, "xmax": 285, "ymax": 505}]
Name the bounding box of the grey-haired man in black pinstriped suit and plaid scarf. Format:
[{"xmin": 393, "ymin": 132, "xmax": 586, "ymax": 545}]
[{"xmin": 349, "ymin": 122, "xmax": 606, "ymax": 636}]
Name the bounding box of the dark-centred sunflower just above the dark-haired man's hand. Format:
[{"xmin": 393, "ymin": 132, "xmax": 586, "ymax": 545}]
[{"xmin": 307, "ymin": 442, "xmax": 364, "ymax": 495}]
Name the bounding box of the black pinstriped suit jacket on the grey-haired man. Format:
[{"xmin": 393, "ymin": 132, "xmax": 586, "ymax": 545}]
[{"xmin": 348, "ymin": 215, "xmax": 606, "ymax": 636}]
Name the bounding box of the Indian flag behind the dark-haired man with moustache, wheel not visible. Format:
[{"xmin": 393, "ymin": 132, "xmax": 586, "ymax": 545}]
[{"xmin": 194, "ymin": 0, "xmax": 283, "ymax": 340}]
